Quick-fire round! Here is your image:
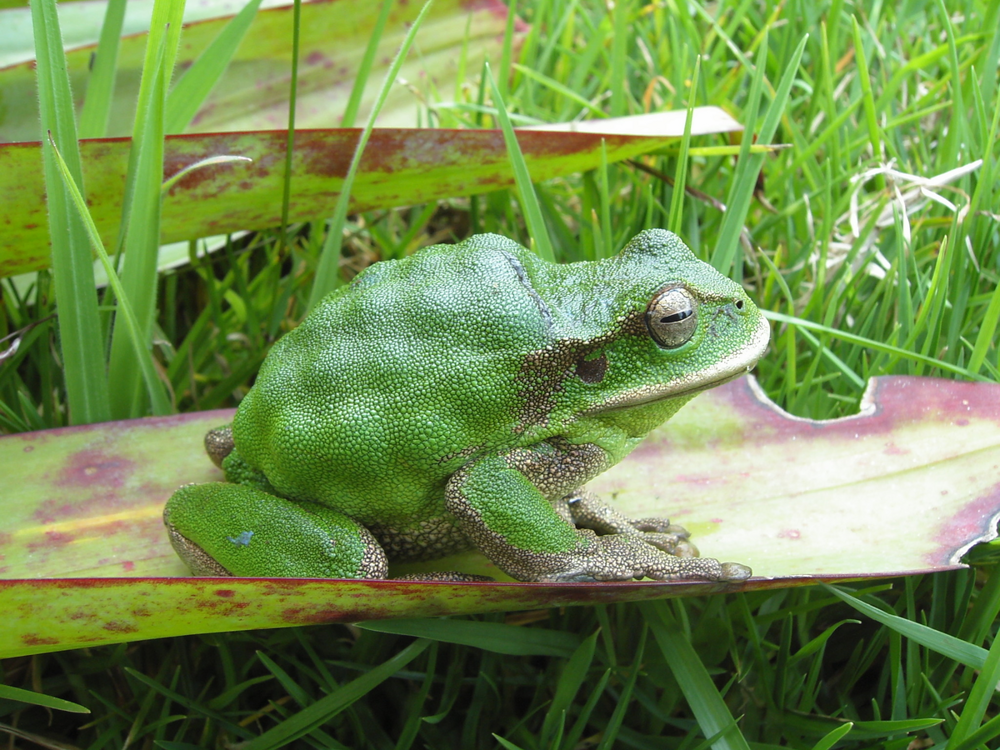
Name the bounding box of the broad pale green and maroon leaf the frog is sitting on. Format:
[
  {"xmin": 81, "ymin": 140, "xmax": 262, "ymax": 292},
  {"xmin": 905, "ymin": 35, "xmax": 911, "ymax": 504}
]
[{"xmin": 0, "ymin": 377, "xmax": 1000, "ymax": 657}]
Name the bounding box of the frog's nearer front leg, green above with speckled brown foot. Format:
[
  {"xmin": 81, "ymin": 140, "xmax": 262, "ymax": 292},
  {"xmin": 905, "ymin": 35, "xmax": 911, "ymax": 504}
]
[{"xmin": 445, "ymin": 444, "xmax": 750, "ymax": 581}]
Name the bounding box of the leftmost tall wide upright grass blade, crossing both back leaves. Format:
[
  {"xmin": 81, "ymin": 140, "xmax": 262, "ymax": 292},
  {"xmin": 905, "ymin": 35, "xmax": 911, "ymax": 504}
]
[{"xmin": 31, "ymin": 0, "xmax": 111, "ymax": 424}]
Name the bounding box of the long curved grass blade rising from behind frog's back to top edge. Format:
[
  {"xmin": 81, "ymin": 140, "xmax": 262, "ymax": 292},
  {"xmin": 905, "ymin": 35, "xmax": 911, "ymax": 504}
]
[{"xmin": 308, "ymin": 0, "xmax": 431, "ymax": 310}]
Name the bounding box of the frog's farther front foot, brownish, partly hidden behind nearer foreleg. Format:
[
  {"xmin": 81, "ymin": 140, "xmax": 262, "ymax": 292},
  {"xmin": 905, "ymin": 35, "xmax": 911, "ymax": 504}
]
[{"xmin": 553, "ymin": 491, "xmax": 698, "ymax": 557}]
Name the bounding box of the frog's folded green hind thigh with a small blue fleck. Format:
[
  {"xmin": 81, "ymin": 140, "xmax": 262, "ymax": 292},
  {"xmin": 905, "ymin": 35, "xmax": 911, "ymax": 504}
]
[{"xmin": 163, "ymin": 482, "xmax": 388, "ymax": 578}]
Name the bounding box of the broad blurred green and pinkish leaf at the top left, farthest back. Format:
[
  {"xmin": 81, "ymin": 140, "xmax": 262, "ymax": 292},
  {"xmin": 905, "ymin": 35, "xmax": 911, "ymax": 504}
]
[{"xmin": 0, "ymin": 0, "xmax": 525, "ymax": 141}]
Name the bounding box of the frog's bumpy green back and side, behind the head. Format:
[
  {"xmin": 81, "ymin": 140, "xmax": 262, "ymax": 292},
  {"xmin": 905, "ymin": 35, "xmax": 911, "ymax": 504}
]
[{"xmin": 234, "ymin": 235, "xmax": 552, "ymax": 523}]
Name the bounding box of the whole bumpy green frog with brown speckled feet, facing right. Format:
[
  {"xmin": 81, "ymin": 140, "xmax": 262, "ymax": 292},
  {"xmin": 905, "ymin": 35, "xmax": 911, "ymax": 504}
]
[{"xmin": 163, "ymin": 229, "xmax": 769, "ymax": 583}]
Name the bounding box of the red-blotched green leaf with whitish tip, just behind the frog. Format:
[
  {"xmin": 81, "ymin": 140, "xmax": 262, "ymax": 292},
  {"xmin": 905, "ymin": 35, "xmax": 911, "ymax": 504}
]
[{"xmin": 0, "ymin": 106, "xmax": 740, "ymax": 277}]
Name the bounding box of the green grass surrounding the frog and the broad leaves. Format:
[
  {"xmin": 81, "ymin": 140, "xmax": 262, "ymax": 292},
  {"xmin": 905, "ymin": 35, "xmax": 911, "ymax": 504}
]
[{"xmin": 0, "ymin": 0, "xmax": 1000, "ymax": 750}]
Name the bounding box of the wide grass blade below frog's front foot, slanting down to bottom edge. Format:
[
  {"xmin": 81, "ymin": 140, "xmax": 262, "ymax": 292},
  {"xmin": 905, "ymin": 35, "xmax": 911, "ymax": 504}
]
[{"xmin": 639, "ymin": 600, "xmax": 750, "ymax": 750}]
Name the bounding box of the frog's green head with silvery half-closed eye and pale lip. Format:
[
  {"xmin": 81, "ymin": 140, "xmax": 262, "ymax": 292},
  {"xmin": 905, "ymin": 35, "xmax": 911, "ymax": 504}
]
[{"xmin": 522, "ymin": 229, "xmax": 769, "ymax": 432}]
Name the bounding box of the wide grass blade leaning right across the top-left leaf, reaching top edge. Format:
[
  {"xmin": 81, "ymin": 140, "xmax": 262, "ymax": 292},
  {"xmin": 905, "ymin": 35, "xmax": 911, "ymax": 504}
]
[{"xmin": 164, "ymin": 0, "xmax": 261, "ymax": 133}]
